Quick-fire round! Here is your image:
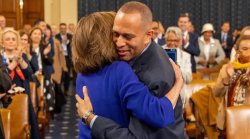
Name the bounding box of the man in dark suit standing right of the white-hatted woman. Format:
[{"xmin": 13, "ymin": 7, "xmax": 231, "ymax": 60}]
[{"xmin": 214, "ymin": 22, "xmax": 233, "ymax": 58}]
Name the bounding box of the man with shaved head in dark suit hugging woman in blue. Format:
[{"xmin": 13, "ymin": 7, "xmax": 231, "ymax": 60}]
[{"xmin": 76, "ymin": 2, "xmax": 187, "ymax": 139}]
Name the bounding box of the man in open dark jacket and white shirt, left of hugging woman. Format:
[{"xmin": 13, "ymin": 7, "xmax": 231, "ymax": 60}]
[{"xmin": 55, "ymin": 23, "xmax": 73, "ymax": 95}]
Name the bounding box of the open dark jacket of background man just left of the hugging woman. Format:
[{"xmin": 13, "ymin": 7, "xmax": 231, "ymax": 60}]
[{"xmin": 55, "ymin": 33, "xmax": 73, "ymax": 68}]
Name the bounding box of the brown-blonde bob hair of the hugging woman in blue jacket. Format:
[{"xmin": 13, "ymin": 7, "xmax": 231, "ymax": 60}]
[{"xmin": 72, "ymin": 12, "xmax": 118, "ymax": 74}]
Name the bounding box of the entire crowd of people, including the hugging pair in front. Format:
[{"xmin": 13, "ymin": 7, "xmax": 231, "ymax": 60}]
[{"xmin": 0, "ymin": 1, "xmax": 250, "ymax": 139}]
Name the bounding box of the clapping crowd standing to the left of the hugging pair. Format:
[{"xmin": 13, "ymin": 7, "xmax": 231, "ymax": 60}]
[{"xmin": 0, "ymin": 15, "xmax": 75, "ymax": 139}]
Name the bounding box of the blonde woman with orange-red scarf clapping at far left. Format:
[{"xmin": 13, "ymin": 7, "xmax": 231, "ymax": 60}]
[{"xmin": 1, "ymin": 29, "xmax": 39, "ymax": 139}]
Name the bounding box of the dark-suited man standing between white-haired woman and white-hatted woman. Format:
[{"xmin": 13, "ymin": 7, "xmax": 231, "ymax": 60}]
[{"xmin": 178, "ymin": 13, "xmax": 200, "ymax": 73}]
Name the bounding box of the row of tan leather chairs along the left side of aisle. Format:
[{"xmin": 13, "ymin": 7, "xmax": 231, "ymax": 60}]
[{"xmin": 0, "ymin": 75, "xmax": 49, "ymax": 139}]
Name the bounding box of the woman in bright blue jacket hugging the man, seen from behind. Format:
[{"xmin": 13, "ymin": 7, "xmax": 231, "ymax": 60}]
[{"xmin": 72, "ymin": 12, "xmax": 183, "ymax": 139}]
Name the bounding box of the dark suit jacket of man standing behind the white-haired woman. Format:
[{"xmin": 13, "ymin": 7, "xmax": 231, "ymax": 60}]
[{"xmin": 183, "ymin": 32, "xmax": 200, "ymax": 73}]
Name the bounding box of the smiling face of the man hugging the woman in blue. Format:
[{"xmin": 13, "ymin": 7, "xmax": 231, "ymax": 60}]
[{"xmin": 113, "ymin": 12, "xmax": 153, "ymax": 61}]
